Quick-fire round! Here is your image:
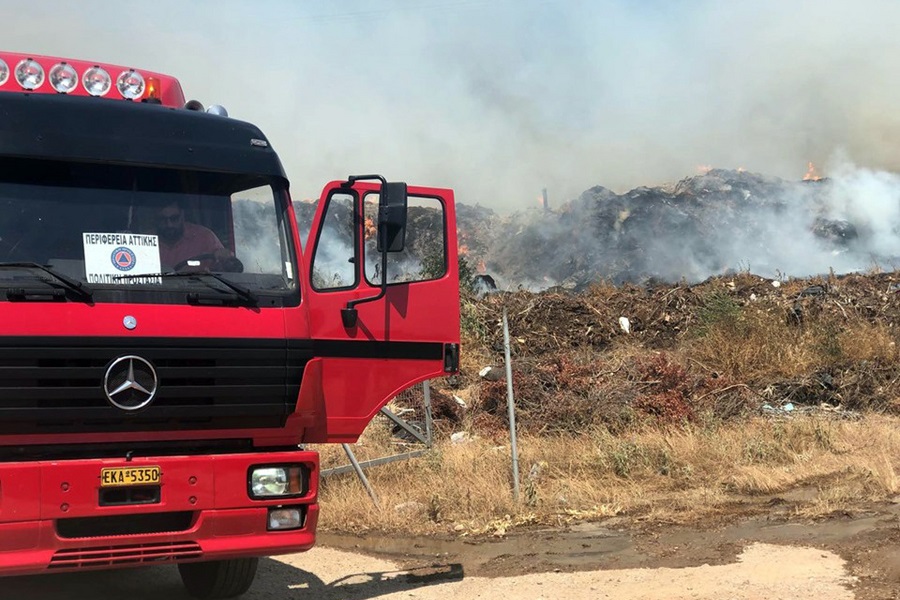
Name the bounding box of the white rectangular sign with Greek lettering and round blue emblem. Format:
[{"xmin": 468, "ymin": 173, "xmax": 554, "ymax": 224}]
[{"xmin": 84, "ymin": 233, "xmax": 162, "ymax": 285}]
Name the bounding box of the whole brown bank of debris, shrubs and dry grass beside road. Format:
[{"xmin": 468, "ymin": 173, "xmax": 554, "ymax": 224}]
[{"xmin": 320, "ymin": 274, "xmax": 900, "ymax": 533}]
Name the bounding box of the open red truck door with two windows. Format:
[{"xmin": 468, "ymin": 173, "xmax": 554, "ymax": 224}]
[{"xmin": 301, "ymin": 181, "xmax": 459, "ymax": 442}]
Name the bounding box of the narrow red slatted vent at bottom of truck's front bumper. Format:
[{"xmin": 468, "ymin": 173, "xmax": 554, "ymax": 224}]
[{"xmin": 50, "ymin": 542, "xmax": 203, "ymax": 569}]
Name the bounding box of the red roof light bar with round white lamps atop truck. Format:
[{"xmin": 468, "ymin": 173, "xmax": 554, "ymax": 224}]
[{"xmin": 0, "ymin": 52, "xmax": 185, "ymax": 108}]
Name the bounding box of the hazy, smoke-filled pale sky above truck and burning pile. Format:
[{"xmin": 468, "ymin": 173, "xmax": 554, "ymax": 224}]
[{"xmin": 0, "ymin": 0, "xmax": 900, "ymax": 209}]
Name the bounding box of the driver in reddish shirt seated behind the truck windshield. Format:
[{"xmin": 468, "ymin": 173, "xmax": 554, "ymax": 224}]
[{"xmin": 154, "ymin": 201, "xmax": 237, "ymax": 270}]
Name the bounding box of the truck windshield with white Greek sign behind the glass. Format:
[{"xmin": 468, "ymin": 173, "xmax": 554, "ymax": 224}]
[{"xmin": 0, "ymin": 158, "xmax": 297, "ymax": 302}]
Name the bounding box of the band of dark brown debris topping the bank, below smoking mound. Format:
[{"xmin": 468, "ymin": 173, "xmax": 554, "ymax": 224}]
[{"xmin": 467, "ymin": 273, "xmax": 900, "ymax": 356}]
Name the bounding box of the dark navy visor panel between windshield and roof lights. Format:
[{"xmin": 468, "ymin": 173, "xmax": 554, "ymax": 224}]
[{"xmin": 0, "ymin": 94, "xmax": 286, "ymax": 180}]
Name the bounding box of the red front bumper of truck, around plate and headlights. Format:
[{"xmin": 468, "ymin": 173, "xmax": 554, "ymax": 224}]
[{"xmin": 0, "ymin": 451, "xmax": 319, "ymax": 575}]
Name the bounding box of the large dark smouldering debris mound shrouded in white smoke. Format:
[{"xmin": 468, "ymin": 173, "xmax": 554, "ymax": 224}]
[{"xmin": 474, "ymin": 166, "xmax": 900, "ymax": 290}]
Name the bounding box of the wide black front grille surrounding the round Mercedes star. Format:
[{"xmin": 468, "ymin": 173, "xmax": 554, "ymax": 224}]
[{"xmin": 0, "ymin": 338, "xmax": 309, "ymax": 433}]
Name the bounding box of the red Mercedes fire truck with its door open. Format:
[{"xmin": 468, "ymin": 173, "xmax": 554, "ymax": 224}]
[{"xmin": 0, "ymin": 52, "xmax": 459, "ymax": 598}]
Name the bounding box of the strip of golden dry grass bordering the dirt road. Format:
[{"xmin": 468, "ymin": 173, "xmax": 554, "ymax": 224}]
[{"xmin": 320, "ymin": 415, "xmax": 900, "ymax": 533}]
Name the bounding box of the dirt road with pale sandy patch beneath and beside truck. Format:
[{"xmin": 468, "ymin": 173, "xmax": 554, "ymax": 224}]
[{"xmin": 0, "ymin": 507, "xmax": 900, "ymax": 600}]
